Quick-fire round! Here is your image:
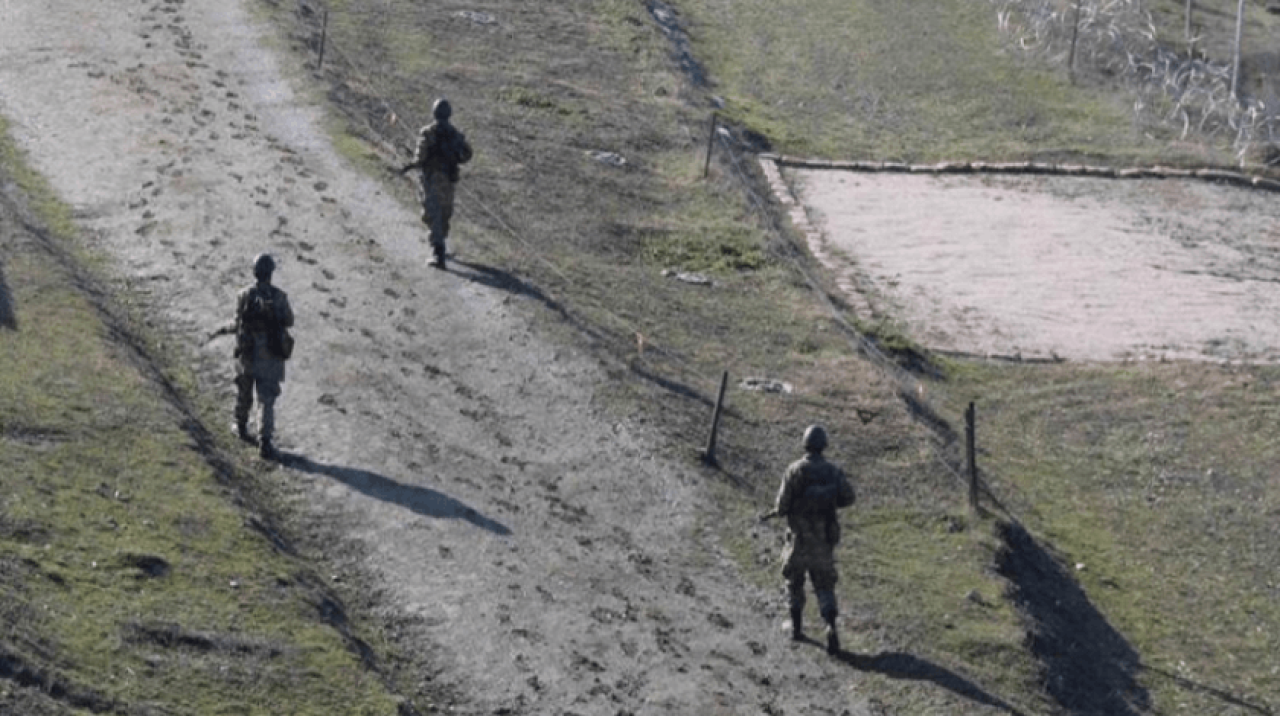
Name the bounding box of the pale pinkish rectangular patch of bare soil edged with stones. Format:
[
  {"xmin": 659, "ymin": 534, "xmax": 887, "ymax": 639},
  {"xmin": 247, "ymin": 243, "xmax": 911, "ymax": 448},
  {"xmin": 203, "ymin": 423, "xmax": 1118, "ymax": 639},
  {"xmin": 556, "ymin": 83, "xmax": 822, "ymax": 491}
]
[{"xmin": 787, "ymin": 170, "xmax": 1280, "ymax": 362}]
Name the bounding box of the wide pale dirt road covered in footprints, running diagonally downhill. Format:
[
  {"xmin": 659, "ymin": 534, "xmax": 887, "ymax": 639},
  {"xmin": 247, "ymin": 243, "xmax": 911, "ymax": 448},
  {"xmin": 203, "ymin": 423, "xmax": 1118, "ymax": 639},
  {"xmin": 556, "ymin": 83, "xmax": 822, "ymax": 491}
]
[{"xmin": 0, "ymin": 0, "xmax": 867, "ymax": 716}]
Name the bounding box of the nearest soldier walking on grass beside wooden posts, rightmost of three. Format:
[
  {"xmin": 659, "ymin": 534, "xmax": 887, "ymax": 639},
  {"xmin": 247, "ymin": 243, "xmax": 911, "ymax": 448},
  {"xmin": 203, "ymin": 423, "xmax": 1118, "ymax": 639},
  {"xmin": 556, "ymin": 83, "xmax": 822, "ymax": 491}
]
[{"xmin": 765, "ymin": 425, "xmax": 855, "ymax": 655}]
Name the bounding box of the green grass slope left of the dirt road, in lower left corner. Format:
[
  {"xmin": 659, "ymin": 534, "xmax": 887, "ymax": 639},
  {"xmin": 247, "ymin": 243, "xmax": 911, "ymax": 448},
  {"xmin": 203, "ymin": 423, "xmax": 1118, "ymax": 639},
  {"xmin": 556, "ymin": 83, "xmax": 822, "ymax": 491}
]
[{"xmin": 0, "ymin": 114, "xmax": 397, "ymax": 715}]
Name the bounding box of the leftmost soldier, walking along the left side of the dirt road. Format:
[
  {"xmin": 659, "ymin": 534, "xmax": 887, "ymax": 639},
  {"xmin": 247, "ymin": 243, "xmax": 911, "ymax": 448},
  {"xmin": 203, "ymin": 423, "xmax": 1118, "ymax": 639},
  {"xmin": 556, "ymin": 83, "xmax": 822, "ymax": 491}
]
[{"xmin": 234, "ymin": 254, "xmax": 293, "ymax": 460}]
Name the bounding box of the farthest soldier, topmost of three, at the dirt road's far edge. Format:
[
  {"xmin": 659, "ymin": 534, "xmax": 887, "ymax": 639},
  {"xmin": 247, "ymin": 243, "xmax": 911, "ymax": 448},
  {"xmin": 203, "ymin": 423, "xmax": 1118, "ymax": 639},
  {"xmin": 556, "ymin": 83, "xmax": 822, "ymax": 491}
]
[{"xmin": 399, "ymin": 97, "xmax": 471, "ymax": 269}]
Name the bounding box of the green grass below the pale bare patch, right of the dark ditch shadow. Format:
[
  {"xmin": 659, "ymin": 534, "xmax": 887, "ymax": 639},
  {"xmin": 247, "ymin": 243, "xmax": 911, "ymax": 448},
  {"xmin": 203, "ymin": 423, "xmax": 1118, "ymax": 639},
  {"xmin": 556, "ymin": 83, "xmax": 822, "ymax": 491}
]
[{"xmin": 959, "ymin": 364, "xmax": 1280, "ymax": 713}]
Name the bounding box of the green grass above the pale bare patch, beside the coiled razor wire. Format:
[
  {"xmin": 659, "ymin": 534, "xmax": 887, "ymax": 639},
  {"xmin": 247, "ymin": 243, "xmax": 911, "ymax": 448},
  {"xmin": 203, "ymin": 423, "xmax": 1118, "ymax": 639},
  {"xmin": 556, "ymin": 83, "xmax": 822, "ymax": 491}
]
[{"xmin": 682, "ymin": 0, "xmax": 1261, "ymax": 164}]
